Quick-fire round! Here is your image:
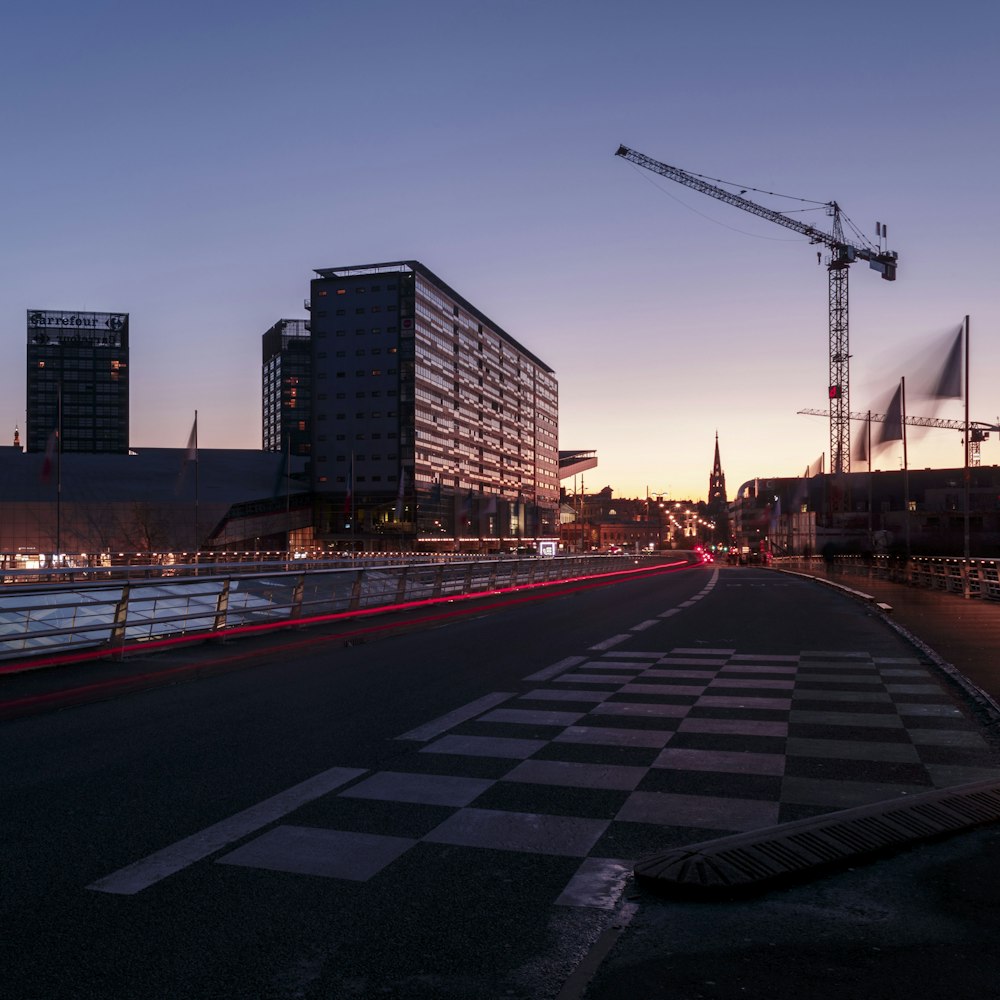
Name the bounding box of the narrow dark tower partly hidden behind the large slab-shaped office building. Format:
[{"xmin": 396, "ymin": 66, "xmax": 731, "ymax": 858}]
[{"xmin": 261, "ymin": 319, "xmax": 312, "ymax": 455}]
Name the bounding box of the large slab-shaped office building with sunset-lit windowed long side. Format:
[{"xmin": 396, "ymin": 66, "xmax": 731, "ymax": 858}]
[{"xmin": 310, "ymin": 260, "xmax": 559, "ymax": 548}]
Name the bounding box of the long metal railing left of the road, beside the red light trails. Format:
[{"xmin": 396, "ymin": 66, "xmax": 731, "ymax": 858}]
[{"xmin": 0, "ymin": 552, "xmax": 695, "ymax": 666}]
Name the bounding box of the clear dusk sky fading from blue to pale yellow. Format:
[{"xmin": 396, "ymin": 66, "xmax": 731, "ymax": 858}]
[{"xmin": 0, "ymin": 0, "xmax": 1000, "ymax": 499}]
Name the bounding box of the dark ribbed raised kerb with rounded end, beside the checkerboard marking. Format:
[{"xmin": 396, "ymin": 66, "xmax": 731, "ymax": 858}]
[{"xmin": 635, "ymin": 780, "xmax": 1000, "ymax": 898}]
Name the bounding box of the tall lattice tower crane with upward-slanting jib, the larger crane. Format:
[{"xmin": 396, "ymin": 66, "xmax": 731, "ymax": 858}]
[{"xmin": 615, "ymin": 146, "xmax": 899, "ymax": 472}]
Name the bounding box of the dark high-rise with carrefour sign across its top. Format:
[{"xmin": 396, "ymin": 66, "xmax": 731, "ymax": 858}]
[{"xmin": 26, "ymin": 309, "xmax": 129, "ymax": 454}]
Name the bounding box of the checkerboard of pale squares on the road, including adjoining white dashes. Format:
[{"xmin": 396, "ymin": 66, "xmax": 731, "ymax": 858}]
[{"xmin": 89, "ymin": 629, "xmax": 1000, "ymax": 907}]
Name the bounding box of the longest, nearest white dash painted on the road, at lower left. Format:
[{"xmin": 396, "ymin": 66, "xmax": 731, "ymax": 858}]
[{"xmin": 87, "ymin": 767, "xmax": 367, "ymax": 896}]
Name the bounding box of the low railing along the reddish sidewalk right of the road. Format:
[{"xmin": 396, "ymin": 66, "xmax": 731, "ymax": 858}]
[{"xmin": 773, "ymin": 556, "xmax": 1000, "ymax": 601}]
